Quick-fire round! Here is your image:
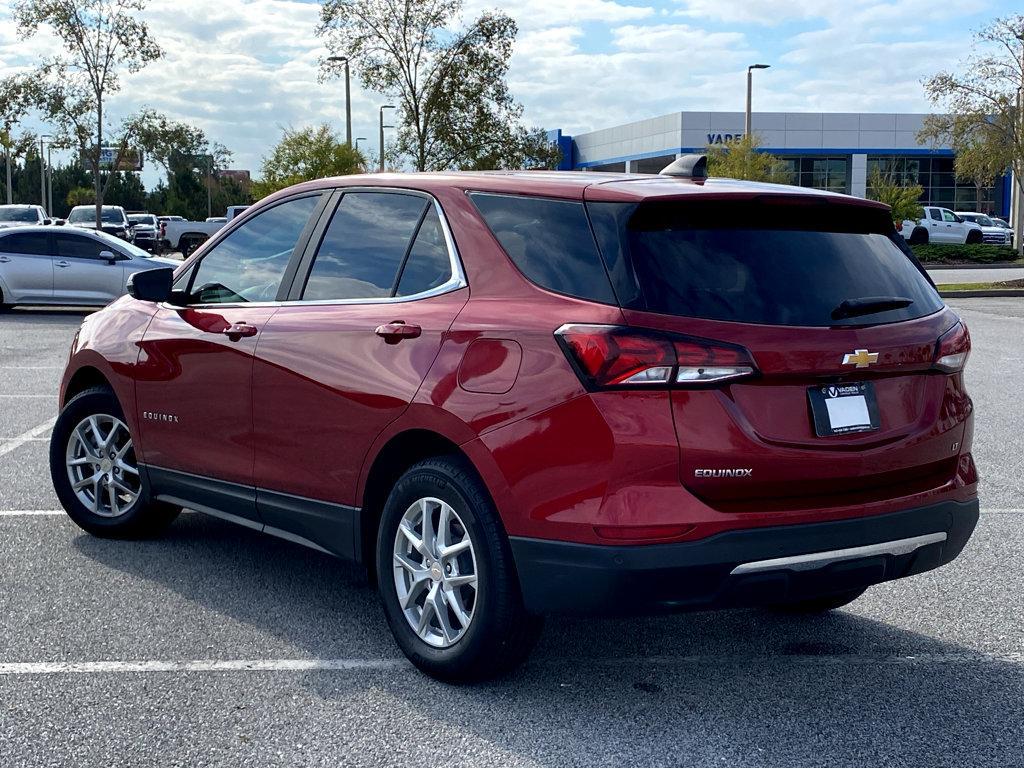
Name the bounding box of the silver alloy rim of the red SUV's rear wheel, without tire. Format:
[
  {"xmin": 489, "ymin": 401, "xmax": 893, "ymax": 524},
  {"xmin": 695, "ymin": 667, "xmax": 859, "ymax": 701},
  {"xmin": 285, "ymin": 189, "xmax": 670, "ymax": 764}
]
[{"xmin": 394, "ymin": 497, "xmax": 477, "ymax": 648}]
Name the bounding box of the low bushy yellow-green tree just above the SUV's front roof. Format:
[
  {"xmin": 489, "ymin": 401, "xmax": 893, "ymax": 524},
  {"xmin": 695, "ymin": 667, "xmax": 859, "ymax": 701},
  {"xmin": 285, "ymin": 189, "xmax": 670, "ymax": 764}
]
[{"xmin": 253, "ymin": 125, "xmax": 366, "ymax": 198}]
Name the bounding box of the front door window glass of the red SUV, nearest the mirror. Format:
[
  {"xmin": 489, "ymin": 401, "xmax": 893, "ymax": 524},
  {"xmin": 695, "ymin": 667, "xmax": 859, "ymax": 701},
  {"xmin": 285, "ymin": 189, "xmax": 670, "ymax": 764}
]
[{"xmin": 189, "ymin": 195, "xmax": 321, "ymax": 304}]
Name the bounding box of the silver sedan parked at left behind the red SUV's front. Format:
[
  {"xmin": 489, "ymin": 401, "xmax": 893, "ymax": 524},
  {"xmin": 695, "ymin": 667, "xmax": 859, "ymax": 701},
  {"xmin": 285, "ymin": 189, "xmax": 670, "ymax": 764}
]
[{"xmin": 0, "ymin": 226, "xmax": 181, "ymax": 307}]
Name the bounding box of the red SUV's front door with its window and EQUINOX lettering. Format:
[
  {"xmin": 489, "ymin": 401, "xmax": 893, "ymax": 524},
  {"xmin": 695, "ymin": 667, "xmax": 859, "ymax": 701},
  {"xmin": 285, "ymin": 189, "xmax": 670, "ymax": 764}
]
[{"xmin": 136, "ymin": 195, "xmax": 321, "ymax": 522}]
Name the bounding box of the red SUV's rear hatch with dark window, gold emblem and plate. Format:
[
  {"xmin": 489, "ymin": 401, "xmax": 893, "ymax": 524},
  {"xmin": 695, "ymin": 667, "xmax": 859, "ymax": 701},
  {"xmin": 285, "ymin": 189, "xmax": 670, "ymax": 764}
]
[{"xmin": 589, "ymin": 195, "xmax": 971, "ymax": 512}]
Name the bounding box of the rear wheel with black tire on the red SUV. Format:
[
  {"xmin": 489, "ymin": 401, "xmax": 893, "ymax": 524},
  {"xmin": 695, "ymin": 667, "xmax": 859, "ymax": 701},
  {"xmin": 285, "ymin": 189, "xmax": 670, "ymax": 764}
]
[{"xmin": 377, "ymin": 456, "xmax": 543, "ymax": 682}]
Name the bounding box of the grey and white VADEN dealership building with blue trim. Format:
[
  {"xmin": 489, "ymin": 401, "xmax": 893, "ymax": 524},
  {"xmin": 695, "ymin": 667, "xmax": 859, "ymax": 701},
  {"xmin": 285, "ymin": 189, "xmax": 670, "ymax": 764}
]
[{"xmin": 553, "ymin": 112, "xmax": 1011, "ymax": 217}]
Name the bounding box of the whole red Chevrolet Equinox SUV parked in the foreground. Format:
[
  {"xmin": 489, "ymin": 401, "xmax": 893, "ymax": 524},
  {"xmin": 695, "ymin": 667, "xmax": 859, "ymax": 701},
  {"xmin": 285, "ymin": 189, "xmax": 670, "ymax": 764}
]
[{"xmin": 50, "ymin": 163, "xmax": 978, "ymax": 680}]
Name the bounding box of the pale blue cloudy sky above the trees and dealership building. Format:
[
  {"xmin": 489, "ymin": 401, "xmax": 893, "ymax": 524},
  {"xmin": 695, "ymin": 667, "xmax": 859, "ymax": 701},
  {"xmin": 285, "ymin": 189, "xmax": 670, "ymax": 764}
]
[{"xmin": 0, "ymin": 0, "xmax": 1020, "ymax": 185}]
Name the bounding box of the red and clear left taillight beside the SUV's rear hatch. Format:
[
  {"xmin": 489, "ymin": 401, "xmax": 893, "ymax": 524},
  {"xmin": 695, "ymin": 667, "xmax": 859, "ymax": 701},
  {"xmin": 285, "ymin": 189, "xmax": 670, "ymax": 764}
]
[{"xmin": 555, "ymin": 324, "xmax": 757, "ymax": 389}]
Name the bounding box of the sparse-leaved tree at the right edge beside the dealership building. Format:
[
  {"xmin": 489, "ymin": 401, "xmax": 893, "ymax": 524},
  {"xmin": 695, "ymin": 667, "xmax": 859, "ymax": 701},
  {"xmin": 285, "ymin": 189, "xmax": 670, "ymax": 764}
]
[{"xmin": 919, "ymin": 14, "xmax": 1024, "ymax": 254}]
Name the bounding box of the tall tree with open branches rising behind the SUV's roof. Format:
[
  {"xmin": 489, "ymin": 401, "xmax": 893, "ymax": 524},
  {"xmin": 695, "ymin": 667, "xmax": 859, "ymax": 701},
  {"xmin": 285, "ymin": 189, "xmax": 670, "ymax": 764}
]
[{"xmin": 316, "ymin": 0, "xmax": 557, "ymax": 171}]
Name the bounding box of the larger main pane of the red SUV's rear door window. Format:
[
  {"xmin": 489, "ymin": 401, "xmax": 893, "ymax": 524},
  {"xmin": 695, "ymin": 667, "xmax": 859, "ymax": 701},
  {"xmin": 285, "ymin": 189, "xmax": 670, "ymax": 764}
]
[{"xmin": 302, "ymin": 193, "xmax": 428, "ymax": 301}]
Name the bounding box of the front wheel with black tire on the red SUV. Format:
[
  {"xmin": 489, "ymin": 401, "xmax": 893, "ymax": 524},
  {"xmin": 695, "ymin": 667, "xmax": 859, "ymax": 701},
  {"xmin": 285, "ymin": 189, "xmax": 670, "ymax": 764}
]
[{"xmin": 50, "ymin": 387, "xmax": 181, "ymax": 539}]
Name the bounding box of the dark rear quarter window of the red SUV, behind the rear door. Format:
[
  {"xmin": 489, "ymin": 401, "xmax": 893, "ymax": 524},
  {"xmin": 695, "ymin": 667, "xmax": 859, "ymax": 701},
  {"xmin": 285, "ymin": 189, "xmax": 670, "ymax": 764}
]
[{"xmin": 470, "ymin": 193, "xmax": 615, "ymax": 304}]
